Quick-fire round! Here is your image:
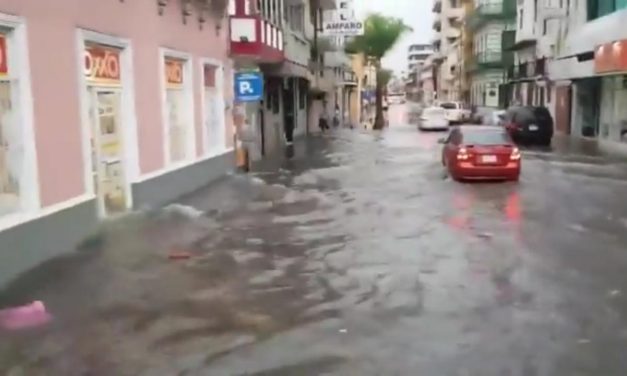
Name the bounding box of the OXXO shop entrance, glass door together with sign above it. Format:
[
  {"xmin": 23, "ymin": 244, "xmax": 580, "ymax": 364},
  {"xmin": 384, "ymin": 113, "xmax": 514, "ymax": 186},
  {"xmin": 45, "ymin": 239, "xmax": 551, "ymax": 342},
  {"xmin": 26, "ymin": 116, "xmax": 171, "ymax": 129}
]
[{"xmin": 83, "ymin": 42, "xmax": 131, "ymax": 217}]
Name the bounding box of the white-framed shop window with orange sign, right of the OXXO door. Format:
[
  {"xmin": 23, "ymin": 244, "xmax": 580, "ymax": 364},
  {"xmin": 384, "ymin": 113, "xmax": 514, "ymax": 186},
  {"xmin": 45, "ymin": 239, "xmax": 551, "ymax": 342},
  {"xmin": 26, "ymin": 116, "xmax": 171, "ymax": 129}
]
[{"xmin": 164, "ymin": 57, "xmax": 194, "ymax": 163}]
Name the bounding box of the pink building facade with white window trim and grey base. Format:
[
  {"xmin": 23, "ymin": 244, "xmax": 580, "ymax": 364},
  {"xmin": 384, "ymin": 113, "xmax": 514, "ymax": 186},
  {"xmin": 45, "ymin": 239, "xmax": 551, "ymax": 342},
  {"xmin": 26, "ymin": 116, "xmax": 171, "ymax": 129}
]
[{"xmin": 0, "ymin": 0, "xmax": 233, "ymax": 283}]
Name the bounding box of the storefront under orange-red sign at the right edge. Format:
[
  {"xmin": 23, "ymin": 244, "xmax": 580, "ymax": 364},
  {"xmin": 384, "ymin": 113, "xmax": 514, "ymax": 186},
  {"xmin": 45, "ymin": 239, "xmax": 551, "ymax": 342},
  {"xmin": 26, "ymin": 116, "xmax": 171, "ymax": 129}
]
[{"xmin": 594, "ymin": 40, "xmax": 627, "ymax": 143}]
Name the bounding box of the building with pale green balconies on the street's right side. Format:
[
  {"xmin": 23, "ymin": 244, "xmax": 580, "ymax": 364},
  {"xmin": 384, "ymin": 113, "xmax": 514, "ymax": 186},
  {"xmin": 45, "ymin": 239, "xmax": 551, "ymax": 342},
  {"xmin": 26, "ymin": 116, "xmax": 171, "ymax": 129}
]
[{"xmin": 466, "ymin": 0, "xmax": 517, "ymax": 111}]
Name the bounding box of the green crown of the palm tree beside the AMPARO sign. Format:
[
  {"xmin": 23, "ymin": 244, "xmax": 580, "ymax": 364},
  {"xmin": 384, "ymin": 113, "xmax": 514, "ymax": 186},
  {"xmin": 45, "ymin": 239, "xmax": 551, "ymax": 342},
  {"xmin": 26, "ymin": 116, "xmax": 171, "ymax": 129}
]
[{"xmin": 345, "ymin": 13, "xmax": 412, "ymax": 60}]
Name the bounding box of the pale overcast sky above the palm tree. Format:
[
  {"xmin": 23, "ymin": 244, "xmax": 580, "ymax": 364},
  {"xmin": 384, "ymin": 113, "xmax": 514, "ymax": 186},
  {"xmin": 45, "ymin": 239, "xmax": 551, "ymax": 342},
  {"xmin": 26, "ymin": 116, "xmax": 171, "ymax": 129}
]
[{"xmin": 354, "ymin": 0, "xmax": 433, "ymax": 75}]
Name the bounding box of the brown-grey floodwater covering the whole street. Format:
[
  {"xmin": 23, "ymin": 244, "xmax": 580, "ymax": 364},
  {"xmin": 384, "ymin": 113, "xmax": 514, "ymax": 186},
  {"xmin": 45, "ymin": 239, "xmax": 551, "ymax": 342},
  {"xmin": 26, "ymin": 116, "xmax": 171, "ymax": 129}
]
[{"xmin": 0, "ymin": 107, "xmax": 627, "ymax": 376}]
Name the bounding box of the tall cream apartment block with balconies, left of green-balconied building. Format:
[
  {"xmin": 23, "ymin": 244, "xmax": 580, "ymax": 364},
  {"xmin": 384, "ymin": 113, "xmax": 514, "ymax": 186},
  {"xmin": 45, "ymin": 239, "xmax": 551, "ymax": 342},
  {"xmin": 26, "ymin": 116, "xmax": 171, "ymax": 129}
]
[{"xmin": 433, "ymin": 0, "xmax": 464, "ymax": 100}]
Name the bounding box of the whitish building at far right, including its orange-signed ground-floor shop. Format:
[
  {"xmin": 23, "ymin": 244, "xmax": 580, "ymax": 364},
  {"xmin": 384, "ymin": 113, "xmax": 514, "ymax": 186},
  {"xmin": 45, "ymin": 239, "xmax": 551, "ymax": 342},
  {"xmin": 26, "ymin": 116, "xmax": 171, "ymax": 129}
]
[{"xmin": 548, "ymin": 0, "xmax": 627, "ymax": 150}]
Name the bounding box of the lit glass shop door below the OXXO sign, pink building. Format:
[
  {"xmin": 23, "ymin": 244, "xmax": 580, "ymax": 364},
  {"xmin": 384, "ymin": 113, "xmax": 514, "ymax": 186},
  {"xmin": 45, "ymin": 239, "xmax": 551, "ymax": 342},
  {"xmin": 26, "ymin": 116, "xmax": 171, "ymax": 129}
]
[{"xmin": 87, "ymin": 86, "xmax": 129, "ymax": 217}]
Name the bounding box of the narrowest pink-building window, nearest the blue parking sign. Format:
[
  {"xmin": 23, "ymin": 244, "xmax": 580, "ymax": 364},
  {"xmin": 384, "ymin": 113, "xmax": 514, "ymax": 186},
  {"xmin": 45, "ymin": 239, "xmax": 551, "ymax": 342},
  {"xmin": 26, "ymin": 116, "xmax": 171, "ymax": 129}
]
[{"xmin": 203, "ymin": 64, "xmax": 226, "ymax": 154}]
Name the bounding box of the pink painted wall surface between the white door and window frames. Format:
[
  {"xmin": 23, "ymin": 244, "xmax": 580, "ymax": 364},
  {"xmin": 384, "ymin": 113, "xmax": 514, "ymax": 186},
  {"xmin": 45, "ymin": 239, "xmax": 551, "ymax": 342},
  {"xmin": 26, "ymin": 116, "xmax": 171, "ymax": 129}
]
[{"xmin": 0, "ymin": 0, "xmax": 231, "ymax": 210}]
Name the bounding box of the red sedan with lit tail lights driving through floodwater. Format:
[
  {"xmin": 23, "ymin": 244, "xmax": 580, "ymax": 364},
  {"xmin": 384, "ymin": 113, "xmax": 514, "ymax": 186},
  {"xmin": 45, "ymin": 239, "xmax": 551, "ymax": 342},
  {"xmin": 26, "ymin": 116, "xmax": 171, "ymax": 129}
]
[{"xmin": 441, "ymin": 125, "xmax": 521, "ymax": 181}]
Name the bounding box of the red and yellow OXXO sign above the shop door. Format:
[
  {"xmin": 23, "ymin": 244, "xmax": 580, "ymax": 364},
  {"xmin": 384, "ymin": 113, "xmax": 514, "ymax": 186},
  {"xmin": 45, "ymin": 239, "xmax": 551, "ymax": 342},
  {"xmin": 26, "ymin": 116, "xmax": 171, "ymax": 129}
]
[{"xmin": 85, "ymin": 45, "xmax": 120, "ymax": 83}]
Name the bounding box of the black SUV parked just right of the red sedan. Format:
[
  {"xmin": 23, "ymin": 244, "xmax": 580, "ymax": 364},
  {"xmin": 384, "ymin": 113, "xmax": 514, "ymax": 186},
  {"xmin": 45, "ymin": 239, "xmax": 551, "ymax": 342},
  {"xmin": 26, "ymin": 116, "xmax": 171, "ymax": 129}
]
[{"xmin": 503, "ymin": 106, "xmax": 554, "ymax": 146}]
